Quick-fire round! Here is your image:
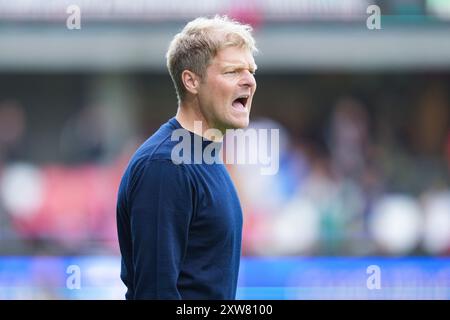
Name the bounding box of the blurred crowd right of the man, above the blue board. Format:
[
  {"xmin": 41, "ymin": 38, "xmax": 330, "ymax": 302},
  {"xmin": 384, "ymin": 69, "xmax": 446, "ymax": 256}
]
[{"xmin": 236, "ymin": 92, "xmax": 450, "ymax": 256}]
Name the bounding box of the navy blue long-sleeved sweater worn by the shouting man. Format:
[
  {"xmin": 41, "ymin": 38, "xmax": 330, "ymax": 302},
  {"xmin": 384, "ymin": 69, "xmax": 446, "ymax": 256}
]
[{"xmin": 117, "ymin": 118, "xmax": 242, "ymax": 299}]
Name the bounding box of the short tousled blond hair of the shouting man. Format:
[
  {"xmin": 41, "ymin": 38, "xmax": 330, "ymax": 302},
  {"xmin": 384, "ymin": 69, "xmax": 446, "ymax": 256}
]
[{"xmin": 166, "ymin": 15, "xmax": 258, "ymax": 102}]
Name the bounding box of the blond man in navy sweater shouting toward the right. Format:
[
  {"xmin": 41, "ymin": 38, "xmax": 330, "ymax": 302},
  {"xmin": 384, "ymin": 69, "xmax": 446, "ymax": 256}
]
[{"xmin": 117, "ymin": 16, "xmax": 257, "ymax": 299}]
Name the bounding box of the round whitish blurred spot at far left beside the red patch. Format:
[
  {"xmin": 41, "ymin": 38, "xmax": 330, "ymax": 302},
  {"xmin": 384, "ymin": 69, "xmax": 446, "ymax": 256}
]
[{"xmin": 0, "ymin": 163, "xmax": 43, "ymax": 218}]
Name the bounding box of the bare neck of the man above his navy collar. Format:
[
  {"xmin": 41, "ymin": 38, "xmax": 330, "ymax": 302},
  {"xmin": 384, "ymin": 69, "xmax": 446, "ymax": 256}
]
[{"xmin": 175, "ymin": 101, "xmax": 223, "ymax": 142}]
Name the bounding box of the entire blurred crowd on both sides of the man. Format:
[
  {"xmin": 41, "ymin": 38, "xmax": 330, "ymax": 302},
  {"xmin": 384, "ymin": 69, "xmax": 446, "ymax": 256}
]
[{"xmin": 0, "ymin": 74, "xmax": 450, "ymax": 256}]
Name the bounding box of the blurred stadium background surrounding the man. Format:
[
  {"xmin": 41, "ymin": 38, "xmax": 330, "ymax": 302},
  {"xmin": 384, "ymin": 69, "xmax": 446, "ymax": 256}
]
[{"xmin": 0, "ymin": 0, "xmax": 450, "ymax": 299}]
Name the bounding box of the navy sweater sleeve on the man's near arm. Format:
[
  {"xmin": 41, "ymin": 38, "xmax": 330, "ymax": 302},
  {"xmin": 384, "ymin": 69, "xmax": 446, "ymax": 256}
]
[{"xmin": 129, "ymin": 160, "xmax": 193, "ymax": 299}]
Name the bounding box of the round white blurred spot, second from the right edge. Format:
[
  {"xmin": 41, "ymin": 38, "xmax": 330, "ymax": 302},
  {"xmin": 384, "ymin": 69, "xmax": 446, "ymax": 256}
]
[{"xmin": 369, "ymin": 195, "xmax": 422, "ymax": 255}]
